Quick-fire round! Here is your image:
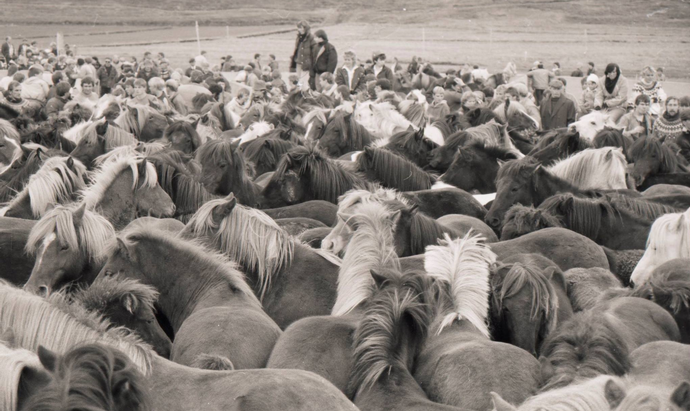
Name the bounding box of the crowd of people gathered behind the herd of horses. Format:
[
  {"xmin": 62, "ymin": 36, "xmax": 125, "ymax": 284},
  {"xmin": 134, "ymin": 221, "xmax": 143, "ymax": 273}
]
[{"xmin": 0, "ymin": 21, "xmax": 690, "ymax": 146}]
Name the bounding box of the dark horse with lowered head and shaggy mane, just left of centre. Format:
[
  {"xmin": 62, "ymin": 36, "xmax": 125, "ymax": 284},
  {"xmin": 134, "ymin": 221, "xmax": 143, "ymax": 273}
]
[{"xmin": 262, "ymin": 145, "xmax": 371, "ymax": 208}]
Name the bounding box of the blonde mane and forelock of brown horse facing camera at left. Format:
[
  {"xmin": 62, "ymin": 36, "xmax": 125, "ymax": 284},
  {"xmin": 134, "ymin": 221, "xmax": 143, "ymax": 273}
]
[{"xmin": 26, "ymin": 205, "xmax": 115, "ymax": 263}]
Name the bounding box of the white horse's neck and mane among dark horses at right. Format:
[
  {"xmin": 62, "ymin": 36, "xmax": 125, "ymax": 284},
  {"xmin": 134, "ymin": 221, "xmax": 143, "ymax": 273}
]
[{"xmin": 547, "ymin": 147, "xmax": 628, "ymax": 190}]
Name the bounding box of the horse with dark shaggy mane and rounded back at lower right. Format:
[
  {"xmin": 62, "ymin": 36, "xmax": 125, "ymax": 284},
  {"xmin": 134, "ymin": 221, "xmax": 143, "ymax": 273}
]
[{"xmin": 540, "ymin": 297, "xmax": 680, "ymax": 391}]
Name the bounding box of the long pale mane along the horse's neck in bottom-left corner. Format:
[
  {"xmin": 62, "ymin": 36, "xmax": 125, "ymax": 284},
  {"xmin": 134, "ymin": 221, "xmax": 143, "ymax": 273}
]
[{"xmin": 0, "ymin": 284, "xmax": 153, "ymax": 375}]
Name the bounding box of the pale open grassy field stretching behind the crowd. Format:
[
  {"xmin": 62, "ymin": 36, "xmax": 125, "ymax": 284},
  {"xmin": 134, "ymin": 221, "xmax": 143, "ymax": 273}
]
[{"xmin": 0, "ymin": 0, "xmax": 690, "ymax": 79}]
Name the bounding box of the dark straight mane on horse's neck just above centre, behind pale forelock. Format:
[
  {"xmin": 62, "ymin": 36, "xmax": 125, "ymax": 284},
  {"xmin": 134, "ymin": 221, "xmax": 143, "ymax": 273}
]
[{"xmin": 357, "ymin": 147, "xmax": 436, "ymax": 191}]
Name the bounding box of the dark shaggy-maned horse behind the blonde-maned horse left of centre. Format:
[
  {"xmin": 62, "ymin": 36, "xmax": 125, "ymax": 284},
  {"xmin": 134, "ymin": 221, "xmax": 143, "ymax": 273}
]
[{"xmin": 195, "ymin": 139, "xmax": 262, "ymax": 207}]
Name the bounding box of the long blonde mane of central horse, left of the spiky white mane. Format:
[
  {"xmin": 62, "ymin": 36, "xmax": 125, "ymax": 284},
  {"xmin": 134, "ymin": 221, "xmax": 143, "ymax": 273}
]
[{"xmin": 331, "ymin": 203, "xmax": 400, "ymax": 316}]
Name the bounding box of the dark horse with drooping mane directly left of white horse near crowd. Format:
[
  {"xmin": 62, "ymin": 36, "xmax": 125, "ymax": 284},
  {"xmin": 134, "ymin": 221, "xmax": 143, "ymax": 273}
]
[{"xmin": 312, "ymin": 111, "xmax": 375, "ymax": 158}]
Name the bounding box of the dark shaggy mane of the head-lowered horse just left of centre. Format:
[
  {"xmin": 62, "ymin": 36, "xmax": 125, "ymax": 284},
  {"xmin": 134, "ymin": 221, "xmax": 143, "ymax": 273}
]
[{"xmin": 269, "ymin": 146, "xmax": 368, "ymax": 204}]
